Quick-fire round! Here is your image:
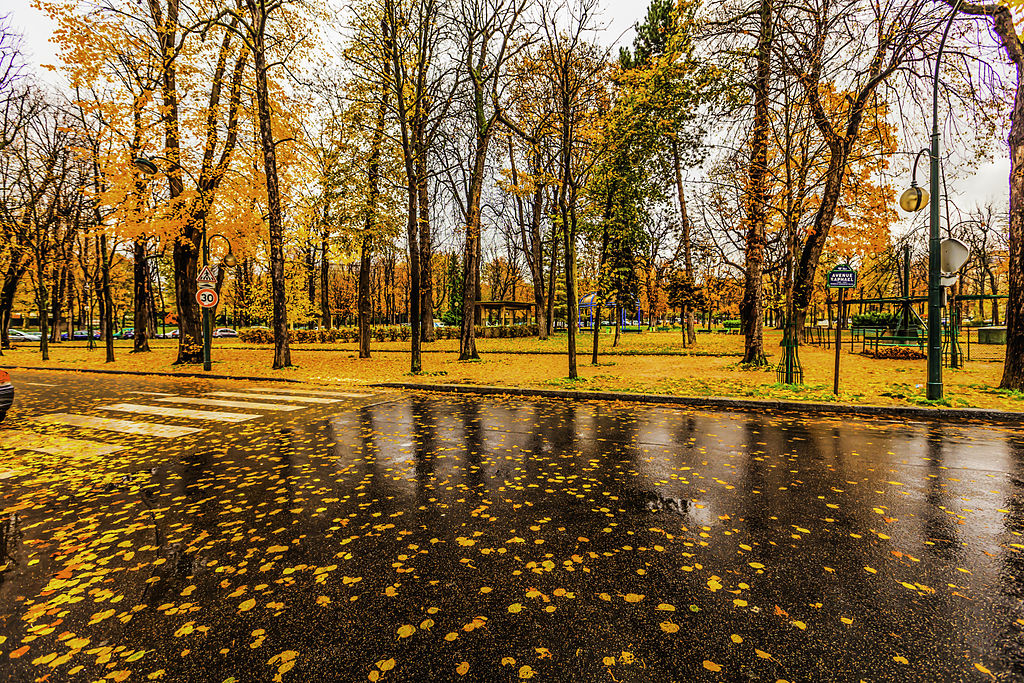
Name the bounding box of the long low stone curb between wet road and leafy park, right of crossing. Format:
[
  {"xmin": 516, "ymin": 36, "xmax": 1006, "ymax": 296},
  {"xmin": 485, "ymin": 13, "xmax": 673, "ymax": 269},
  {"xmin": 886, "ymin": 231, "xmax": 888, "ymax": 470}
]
[{"xmin": 370, "ymin": 382, "xmax": 1024, "ymax": 424}]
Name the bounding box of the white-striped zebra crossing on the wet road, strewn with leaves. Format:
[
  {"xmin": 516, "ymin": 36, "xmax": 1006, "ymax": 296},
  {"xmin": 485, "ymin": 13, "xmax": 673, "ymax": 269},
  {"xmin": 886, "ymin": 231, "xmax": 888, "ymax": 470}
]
[{"xmin": 0, "ymin": 387, "xmax": 374, "ymax": 456}]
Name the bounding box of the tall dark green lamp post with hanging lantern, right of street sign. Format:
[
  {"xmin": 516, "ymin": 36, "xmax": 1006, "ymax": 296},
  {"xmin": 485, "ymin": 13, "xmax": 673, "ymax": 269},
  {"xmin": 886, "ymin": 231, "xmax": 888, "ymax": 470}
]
[{"xmin": 900, "ymin": 0, "xmax": 961, "ymax": 400}]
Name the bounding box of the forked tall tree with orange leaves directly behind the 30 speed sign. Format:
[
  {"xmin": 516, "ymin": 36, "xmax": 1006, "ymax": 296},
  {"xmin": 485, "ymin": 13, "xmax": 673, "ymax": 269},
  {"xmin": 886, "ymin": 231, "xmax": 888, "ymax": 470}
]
[{"xmin": 42, "ymin": 0, "xmax": 249, "ymax": 364}]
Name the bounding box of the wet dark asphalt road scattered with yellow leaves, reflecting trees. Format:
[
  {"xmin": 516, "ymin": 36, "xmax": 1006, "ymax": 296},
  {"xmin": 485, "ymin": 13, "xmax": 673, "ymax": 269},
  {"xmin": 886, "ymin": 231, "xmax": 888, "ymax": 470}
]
[{"xmin": 0, "ymin": 373, "xmax": 1024, "ymax": 682}]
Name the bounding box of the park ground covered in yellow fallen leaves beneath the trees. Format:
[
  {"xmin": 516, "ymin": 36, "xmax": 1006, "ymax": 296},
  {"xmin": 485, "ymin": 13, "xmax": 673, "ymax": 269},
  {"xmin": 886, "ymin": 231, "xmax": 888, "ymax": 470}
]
[{"xmin": 6, "ymin": 330, "xmax": 1024, "ymax": 411}]
